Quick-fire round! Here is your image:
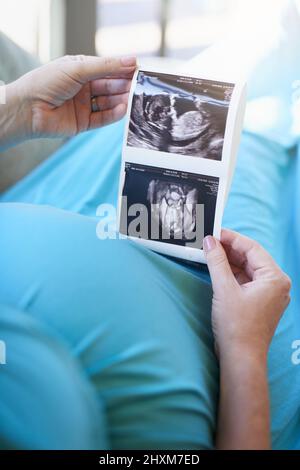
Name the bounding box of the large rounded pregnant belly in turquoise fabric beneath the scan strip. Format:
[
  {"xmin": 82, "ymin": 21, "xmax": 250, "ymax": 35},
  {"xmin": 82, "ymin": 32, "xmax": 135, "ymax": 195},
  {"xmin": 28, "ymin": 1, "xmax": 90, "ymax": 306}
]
[{"xmin": 0, "ymin": 204, "xmax": 218, "ymax": 448}]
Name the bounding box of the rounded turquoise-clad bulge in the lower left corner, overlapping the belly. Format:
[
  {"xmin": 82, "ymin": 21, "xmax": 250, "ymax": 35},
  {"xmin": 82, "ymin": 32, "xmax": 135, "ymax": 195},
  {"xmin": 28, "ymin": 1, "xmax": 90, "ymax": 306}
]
[{"xmin": 0, "ymin": 305, "xmax": 108, "ymax": 449}]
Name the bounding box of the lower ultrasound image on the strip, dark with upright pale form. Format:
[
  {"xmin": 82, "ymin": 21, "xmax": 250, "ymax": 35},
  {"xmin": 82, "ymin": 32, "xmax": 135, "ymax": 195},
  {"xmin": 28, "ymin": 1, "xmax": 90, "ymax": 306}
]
[{"xmin": 121, "ymin": 163, "xmax": 219, "ymax": 248}]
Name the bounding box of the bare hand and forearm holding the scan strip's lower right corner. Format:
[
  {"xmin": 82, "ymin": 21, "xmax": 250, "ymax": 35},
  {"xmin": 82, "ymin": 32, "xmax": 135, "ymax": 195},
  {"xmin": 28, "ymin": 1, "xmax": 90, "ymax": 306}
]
[{"xmin": 204, "ymin": 230, "xmax": 291, "ymax": 450}]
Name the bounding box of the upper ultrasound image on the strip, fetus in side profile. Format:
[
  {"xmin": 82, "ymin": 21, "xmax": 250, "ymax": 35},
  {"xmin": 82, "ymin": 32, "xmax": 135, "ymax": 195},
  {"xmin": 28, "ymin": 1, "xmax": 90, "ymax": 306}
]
[{"xmin": 127, "ymin": 71, "xmax": 234, "ymax": 161}]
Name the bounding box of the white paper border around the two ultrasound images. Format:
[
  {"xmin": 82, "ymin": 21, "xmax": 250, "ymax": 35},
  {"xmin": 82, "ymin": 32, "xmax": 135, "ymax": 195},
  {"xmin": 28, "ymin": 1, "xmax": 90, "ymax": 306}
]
[{"xmin": 118, "ymin": 63, "xmax": 247, "ymax": 263}]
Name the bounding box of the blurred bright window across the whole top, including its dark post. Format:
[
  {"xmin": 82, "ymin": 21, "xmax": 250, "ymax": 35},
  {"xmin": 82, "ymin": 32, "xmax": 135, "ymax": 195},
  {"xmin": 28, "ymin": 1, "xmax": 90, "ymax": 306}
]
[{"xmin": 0, "ymin": 0, "xmax": 288, "ymax": 61}]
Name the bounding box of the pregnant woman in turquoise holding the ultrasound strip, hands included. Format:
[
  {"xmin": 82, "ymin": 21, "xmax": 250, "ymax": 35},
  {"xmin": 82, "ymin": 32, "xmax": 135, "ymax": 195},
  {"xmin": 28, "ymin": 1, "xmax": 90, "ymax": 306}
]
[{"xmin": 0, "ymin": 56, "xmax": 300, "ymax": 449}]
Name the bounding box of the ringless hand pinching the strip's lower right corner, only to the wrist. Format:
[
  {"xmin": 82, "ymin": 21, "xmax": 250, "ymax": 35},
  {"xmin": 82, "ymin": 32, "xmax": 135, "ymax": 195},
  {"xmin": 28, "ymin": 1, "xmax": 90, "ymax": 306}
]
[{"xmin": 204, "ymin": 230, "xmax": 291, "ymax": 360}]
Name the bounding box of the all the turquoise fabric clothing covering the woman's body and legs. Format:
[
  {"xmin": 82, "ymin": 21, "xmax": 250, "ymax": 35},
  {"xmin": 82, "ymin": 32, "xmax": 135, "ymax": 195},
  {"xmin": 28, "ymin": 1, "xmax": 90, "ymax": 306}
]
[{"xmin": 0, "ymin": 117, "xmax": 300, "ymax": 449}]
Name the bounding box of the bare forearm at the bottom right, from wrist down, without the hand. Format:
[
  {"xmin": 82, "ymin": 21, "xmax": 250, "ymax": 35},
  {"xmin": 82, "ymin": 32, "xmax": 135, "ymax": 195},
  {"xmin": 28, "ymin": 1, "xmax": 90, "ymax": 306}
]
[{"xmin": 216, "ymin": 349, "xmax": 270, "ymax": 450}]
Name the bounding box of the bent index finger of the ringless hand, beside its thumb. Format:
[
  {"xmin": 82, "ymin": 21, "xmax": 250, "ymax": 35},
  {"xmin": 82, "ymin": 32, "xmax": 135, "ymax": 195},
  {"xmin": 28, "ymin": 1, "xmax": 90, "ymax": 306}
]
[{"xmin": 221, "ymin": 230, "xmax": 278, "ymax": 278}]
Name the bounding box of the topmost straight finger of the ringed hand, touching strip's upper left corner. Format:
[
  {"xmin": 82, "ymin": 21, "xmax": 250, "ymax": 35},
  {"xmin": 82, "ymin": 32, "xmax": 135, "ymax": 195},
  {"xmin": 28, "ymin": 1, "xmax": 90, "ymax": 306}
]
[{"xmin": 61, "ymin": 55, "xmax": 136, "ymax": 84}]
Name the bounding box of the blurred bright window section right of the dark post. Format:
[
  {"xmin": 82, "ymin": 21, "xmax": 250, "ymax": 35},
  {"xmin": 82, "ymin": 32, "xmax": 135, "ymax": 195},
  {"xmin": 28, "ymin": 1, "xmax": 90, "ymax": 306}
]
[{"xmin": 96, "ymin": 0, "xmax": 237, "ymax": 58}]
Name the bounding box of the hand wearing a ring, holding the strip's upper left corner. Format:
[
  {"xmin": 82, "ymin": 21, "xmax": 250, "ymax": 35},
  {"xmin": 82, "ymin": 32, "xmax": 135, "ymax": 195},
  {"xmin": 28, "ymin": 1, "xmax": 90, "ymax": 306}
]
[{"xmin": 0, "ymin": 55, "xmax": 136, "ymax": 146}]
